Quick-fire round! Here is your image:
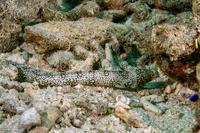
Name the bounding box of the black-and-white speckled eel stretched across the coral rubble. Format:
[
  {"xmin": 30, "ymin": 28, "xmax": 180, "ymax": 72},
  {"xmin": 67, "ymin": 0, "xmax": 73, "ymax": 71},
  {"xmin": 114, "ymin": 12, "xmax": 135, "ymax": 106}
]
[{"xmin": 11, "ymin": 62, "xmax": 156, "ymax": 88}]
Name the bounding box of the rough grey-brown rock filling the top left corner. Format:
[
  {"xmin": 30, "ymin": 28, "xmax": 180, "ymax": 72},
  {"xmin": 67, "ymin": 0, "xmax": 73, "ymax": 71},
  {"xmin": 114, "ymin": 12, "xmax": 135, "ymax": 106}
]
[{"xmin": 0, "ymin": 0, "xmax": 58, "ymax": 26}]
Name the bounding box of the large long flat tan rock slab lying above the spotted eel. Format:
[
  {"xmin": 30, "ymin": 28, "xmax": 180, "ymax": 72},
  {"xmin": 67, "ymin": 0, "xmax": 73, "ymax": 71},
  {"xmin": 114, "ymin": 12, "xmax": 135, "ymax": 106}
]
[{"xmin": 24, "ymin": 18, "xmax": 132, "ymax": 53}]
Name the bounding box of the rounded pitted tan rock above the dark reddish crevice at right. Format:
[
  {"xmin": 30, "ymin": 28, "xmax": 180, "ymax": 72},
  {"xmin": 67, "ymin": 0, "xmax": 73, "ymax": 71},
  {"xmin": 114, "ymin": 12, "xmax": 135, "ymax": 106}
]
[{"xmin": 149, "ymin": 24, "xmax": 196, "ymax": 61}]
